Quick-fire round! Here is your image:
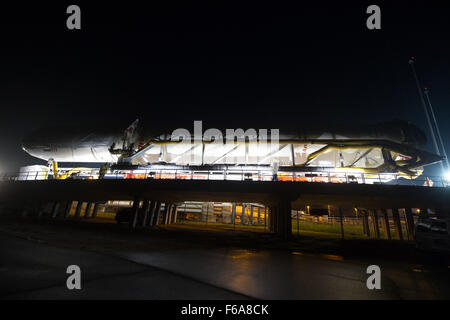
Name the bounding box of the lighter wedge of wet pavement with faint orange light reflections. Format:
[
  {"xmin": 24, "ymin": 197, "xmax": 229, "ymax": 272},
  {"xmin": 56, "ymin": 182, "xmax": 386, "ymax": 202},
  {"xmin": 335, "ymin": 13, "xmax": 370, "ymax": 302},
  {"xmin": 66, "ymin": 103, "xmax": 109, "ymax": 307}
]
[{"xmin": 119, "ymin": 249, "xmax": 400, "ymax": 299}]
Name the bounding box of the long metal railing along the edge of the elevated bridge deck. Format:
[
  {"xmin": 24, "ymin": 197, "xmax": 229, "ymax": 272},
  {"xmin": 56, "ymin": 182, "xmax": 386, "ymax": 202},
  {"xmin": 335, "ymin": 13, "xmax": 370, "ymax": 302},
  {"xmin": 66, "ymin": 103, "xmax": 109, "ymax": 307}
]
[{"xmin": 0, "ymin": 169, "xmax": 450, "ymax": 187}]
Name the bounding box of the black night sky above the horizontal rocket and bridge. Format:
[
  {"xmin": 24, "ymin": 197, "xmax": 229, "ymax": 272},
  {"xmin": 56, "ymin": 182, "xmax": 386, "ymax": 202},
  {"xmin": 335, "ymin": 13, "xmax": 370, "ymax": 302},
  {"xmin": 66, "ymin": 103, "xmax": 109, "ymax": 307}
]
[{"xmin": 0, "ymin": 1, "xmax": 450, "ymax": 174}]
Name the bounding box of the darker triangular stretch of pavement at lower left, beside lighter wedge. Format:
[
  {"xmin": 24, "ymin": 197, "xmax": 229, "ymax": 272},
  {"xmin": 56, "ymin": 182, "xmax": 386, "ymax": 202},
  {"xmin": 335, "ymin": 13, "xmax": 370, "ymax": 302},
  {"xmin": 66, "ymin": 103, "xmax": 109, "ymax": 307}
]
[{"xmin": 0, "ymin": 234, "xmax": 247, "ymax": 299}]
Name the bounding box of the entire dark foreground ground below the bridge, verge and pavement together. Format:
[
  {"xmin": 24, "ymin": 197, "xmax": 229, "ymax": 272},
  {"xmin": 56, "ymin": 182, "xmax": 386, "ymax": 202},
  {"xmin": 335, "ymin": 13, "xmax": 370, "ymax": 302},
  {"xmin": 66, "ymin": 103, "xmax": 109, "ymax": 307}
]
[{"xmin": 0, "ymin": 216, "xmax": 450, "ymax": 300}]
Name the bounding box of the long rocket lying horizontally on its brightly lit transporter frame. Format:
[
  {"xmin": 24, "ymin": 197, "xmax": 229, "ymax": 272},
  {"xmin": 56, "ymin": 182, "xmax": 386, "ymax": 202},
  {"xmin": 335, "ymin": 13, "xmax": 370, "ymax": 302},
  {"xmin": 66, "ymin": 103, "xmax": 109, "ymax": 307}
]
[{"xmin": 23, "ymin": 120, "xmax": 442, "ymax": 183}]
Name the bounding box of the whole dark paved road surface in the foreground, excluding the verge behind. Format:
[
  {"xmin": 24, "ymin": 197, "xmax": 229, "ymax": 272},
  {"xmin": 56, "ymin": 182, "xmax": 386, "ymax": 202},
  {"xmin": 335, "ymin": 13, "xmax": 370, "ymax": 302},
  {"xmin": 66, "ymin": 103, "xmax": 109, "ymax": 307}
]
[{"xmin": 0, "ymin": 234, "xmax": 450, "ymax": 299}]
